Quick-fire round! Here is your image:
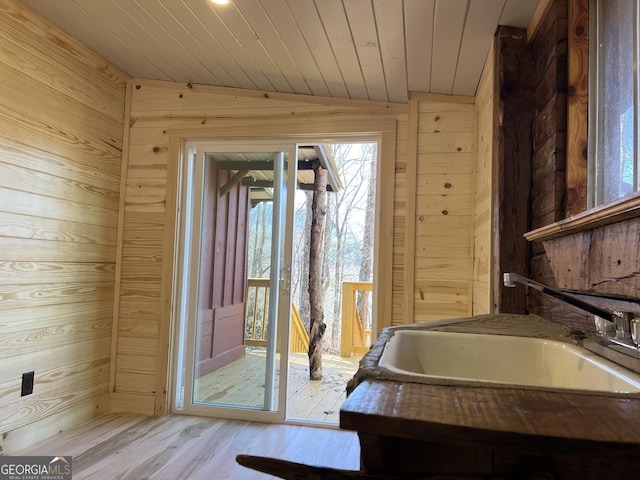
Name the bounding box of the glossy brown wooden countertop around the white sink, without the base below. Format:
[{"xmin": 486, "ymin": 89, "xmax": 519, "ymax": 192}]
[{"xmin": 340, "ymin": 316, "xmax": 640, "ymax": 459}]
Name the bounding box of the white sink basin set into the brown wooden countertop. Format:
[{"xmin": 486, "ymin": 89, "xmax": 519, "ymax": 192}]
[{"xmin": 379, "ymin": 330, "xmax": 640, "ymax": 393}]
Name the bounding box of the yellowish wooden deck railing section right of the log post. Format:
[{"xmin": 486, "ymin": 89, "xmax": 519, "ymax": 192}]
[{"xmin": 340, "ymin": 282, "xmax": 373, "ymax": 357}]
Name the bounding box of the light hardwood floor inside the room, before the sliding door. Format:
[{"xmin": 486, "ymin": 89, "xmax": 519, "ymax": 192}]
[{"xmin": 20, "ymin": 414, "xmax": 360, "ymax": 480}]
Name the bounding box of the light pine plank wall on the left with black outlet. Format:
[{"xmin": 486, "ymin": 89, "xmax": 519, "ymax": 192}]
[{"xmin": 0, "ymin": 0, "xmax": 128, "ymax": 454}]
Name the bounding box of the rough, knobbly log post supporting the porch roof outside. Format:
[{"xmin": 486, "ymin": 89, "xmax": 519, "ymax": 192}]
[{"xmin": 309, "ymin": 162, "xmax": 327, "ymax": 380}]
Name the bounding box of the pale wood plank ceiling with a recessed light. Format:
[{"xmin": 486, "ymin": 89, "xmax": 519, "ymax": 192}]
[{"xmin": 23, "ymin": 0, "xmax": 538, "ymax": 103}]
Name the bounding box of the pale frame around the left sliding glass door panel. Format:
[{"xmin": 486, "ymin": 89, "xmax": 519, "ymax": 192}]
[{"xmin": 171, "ymin": 140, "xmax": 297, "ymax": 422}]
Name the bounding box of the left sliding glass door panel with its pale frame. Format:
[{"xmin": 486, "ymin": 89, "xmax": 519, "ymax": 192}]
[{"xmin": 175, "ymin": 142, "xmax": 297, "ymax": 420}]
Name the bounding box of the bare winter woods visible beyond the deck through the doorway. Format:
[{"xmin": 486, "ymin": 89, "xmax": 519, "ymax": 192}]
[{"xmin": 250, "ymin": 144, "xmax": 376, "ymax": 360}]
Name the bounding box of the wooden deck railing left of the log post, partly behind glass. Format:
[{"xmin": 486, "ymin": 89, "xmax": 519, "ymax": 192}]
[{"xmin": 244, "ymin": 278, "xmax": 309, "ymax": 353}]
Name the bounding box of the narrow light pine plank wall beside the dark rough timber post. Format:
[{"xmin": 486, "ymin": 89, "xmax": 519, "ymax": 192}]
[{"xmin": 473, "ymin": 45, "xmax": 497, "ymax": 315}]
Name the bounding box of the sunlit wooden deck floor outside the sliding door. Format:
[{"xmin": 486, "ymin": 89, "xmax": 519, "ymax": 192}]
[{"xmin": 195, "ymin": 347, "xmax": 360, "ymax": 424}]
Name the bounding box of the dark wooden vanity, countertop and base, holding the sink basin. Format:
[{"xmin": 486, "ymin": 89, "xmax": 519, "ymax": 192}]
[{"xmin": 340, "ymin": 314, "xmax": 640, "ymax": 480}]
